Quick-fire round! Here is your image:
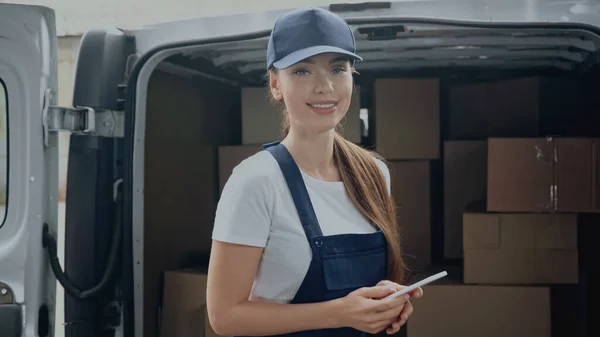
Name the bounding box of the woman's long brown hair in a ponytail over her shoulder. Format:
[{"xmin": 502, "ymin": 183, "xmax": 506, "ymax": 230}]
[{"xmin": 267, "ymin": 69, "xmax": 407, "ymax": 284}]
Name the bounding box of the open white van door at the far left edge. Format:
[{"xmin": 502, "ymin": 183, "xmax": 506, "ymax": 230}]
[{"xmin": 0, "ymin": 4, "xmax": 58, "ymax": 337}]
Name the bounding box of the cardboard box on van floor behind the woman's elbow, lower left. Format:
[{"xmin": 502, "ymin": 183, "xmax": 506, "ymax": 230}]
[{"xmin": 160, "ymin": 269, "xmax": 227, "ymax": 337}]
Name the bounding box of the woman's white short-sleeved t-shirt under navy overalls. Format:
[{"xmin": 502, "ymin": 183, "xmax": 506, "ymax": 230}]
[{"xmin": 212, "ymin": 151, "xmax": 390, "ymax": 303}]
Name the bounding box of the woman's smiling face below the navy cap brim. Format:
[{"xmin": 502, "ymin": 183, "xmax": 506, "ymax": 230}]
[{"xmin": 269, "ymin": 54, "xmax": 353, "ymax": 134}]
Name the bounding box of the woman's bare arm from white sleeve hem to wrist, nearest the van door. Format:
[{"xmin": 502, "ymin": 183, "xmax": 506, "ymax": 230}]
[{"xmin": 207, "ymin": 241, "xmax": 340, "ymax": 336}]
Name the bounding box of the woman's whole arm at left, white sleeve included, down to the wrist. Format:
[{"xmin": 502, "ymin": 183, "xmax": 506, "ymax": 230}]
[{"xmin": 207, "ymin": 160, "xmax": 336, "ymax": 336}]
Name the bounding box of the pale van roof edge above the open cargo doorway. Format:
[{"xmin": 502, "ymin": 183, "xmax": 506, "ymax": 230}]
[{"xmin": 127, "ymin": 0, "xmax": 600, "ymax": 54}]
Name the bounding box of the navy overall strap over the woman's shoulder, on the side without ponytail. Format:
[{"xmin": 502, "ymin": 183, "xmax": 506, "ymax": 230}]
[{"xmin": 263, "ymin": 143, "xmax": 323, "ymax": 239}]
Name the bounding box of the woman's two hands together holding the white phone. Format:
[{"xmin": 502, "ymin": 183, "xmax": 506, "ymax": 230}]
[{"xmin": 337, "ymin": 283, "xmax": 408, "ymax": 334}]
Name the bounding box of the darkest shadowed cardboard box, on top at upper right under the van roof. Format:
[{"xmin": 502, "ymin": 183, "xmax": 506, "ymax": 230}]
[{"xmin": 448, "ymin": 76, "xmax": 588, "ymax": 140}]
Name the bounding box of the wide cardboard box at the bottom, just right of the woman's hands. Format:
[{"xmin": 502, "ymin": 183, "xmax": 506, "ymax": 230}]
[{"xmin": 407, "ymin": 285, "xmax": 551, "ymax": 337}]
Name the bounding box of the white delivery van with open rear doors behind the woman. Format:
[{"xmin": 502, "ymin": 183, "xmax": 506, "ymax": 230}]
[{"xmin": 0, "ymin": 0, "xmax": 600, "ymax": 337}]
